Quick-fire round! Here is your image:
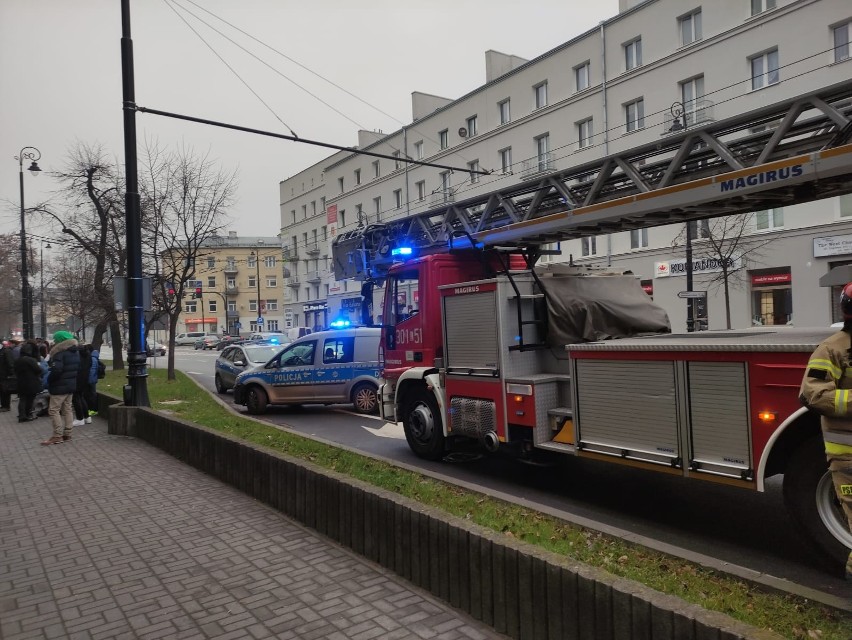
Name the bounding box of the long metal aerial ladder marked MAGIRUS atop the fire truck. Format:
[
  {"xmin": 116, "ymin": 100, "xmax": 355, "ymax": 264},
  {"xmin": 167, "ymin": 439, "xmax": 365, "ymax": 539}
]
[{"xmin": 332, "ymin": 81, "xmax": 852, "ymax": 281}]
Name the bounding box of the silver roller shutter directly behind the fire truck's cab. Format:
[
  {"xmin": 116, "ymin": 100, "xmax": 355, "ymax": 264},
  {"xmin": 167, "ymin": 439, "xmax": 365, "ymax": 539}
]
[{"xmin": 444, "ymin": 291, "xmax": 500, "ymax": 376}]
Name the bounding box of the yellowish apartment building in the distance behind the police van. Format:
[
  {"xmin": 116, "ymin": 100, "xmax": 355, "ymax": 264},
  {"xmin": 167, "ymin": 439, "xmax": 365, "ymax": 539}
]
[{"xmin": 178, "ymin": 231, "xmax": 288, "ymax": 335}]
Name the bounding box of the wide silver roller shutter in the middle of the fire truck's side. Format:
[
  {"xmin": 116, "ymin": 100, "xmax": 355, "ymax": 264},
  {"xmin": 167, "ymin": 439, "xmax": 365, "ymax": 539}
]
[{"xmin": 575, "ymin": 359, "xmax": 680, "ymax": 466}]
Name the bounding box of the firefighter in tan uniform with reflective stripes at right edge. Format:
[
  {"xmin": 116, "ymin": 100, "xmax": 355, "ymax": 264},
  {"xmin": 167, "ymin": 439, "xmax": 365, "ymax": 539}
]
[{"xmin": 799, "ymin": 282, "xmax": 852, "ymax": 580}]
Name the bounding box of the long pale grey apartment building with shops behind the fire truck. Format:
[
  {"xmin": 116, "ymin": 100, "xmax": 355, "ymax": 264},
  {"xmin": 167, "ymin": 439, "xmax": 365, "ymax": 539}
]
[{"xmin": 280, "ymin": 0, "xmax": 852, "ymax": 331}]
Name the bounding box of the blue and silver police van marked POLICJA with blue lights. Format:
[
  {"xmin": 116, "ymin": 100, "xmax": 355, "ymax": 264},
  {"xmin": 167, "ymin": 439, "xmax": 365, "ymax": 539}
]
[{"xmin": 234, "ymin": 327, "xmax": 381, "ymax": 414}]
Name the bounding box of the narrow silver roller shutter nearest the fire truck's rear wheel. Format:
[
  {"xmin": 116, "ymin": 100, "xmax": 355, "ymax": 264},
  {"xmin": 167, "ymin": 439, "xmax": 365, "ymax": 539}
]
[{"xmin": 688, "ymin": 362, "xmax": 752, "ymax": 478}]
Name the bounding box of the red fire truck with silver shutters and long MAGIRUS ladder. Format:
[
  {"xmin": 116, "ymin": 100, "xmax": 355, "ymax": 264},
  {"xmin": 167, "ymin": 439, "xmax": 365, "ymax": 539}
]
[{"xmin": 332, "ymin": 83, "xmax": 852, "ymax": 558}]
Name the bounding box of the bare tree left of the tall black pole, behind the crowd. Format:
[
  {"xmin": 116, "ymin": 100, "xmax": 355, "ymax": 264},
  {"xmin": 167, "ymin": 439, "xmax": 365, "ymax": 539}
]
[{"xmin": 35, "ymin": 142, "xmax": 127, "ymax": 369}]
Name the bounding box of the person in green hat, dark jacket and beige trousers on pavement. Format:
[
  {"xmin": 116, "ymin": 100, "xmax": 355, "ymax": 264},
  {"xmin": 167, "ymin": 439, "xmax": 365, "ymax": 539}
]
[{"xmin": 42, "ymin": 331, "xmax": 80, "ymax": 445}]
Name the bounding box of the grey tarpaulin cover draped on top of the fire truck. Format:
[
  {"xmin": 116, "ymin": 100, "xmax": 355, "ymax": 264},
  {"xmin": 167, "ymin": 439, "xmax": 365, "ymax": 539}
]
[{"xmin": 540, "ymin": 270, "xmax": 671, "ymax": 346}]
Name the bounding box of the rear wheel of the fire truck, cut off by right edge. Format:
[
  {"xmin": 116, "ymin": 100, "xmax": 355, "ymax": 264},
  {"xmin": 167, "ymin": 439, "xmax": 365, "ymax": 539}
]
[{"xmin": 784, "ymin": 436, "xmax": 852, "ymax": 567}]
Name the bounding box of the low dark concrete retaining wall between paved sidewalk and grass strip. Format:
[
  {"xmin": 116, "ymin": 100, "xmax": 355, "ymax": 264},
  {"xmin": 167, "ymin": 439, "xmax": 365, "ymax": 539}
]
[{"xmin": 104, "ymin": 404, "xmax": 779, "ymax": 640}]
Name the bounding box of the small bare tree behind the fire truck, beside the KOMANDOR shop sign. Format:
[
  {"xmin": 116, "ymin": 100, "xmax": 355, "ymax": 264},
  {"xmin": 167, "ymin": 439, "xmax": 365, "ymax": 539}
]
[{"xmin": 672, "ymin": 213, "xmax": 770, "ymax": 329}]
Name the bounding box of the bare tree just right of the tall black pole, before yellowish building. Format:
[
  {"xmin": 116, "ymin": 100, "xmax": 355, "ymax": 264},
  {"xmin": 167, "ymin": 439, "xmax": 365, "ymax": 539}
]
[{"xmin": 140, "ymin": 143, "xmax": 237, "ymax": 380}]
